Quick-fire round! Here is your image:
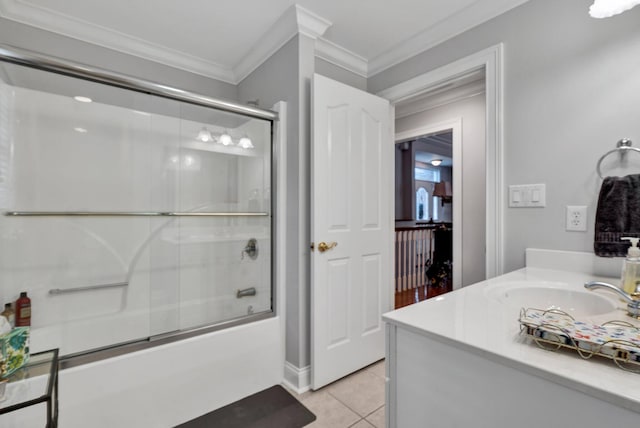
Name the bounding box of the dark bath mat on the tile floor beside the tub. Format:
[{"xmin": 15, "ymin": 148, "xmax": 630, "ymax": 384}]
[{"xmin": 176, "ymin": 385, "xmax": 316, "ymax": 428}]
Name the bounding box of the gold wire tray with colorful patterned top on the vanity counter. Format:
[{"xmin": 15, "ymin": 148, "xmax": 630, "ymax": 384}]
[{"xmin": 519, "ymin": 308, "xmax": 640, "ymax": 373}]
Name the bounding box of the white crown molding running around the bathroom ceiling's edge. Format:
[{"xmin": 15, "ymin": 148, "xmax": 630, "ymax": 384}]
[{"xmin": 0, "ymin": 0, "xmax": 528, "ymax": 85}]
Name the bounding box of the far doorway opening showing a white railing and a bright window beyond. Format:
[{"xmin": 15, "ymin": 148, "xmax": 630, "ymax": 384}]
[{"xmin": 395, "ymin": 129, "xmax": 454, "ymax": 309}]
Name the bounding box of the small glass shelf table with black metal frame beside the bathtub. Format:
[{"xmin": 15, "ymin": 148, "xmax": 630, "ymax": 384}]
[{"xmin": 0, "ymin": 349, "xmax": 58, "ymax": 428}]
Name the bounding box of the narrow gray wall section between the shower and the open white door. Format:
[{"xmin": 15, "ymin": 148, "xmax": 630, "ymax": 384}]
[{"xmin": 238, "ymin": 34, "xmax": 315, "ymax": 368}]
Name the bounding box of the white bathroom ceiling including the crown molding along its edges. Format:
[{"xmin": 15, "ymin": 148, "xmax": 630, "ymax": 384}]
[{"xmin": 0, "ymin": 0, "xmax": 527, "ymax": 84}]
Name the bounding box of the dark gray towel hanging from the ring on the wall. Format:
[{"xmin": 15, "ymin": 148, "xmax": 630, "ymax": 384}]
[{"xmin": 593, "ymin": 174, "xmax": 640, "ymax": 257}]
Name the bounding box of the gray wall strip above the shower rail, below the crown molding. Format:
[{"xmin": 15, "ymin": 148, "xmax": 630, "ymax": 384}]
[{"xmin": 0, "ymin": 18, "xmax": 237, "ymax": 100}]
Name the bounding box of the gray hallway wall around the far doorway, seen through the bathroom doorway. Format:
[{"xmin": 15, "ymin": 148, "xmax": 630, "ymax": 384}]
[{"xmin": 396, "ymin": 94, "xmax": 486, "ymax": 285}]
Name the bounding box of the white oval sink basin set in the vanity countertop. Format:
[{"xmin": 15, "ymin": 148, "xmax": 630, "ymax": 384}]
[{"xmin": 485, "ymin": 281, "xmax": 618, "ymax": 317}]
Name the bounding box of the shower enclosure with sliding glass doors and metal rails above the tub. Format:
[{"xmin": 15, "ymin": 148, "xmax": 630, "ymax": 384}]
[{"xmin": 0, "ymin": 47, "xmax": 277, "ymax": 360}]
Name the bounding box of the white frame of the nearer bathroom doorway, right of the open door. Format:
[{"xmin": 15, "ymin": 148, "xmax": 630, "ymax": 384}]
[{"xmin": 377, "ymin": 43, "xmax": 504, "ymax": 278}]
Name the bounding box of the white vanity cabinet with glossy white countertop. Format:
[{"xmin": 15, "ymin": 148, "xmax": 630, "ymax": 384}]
[{"xmin": 383, "ymin": 268, "xmax": 640, "ymax": 428}]
